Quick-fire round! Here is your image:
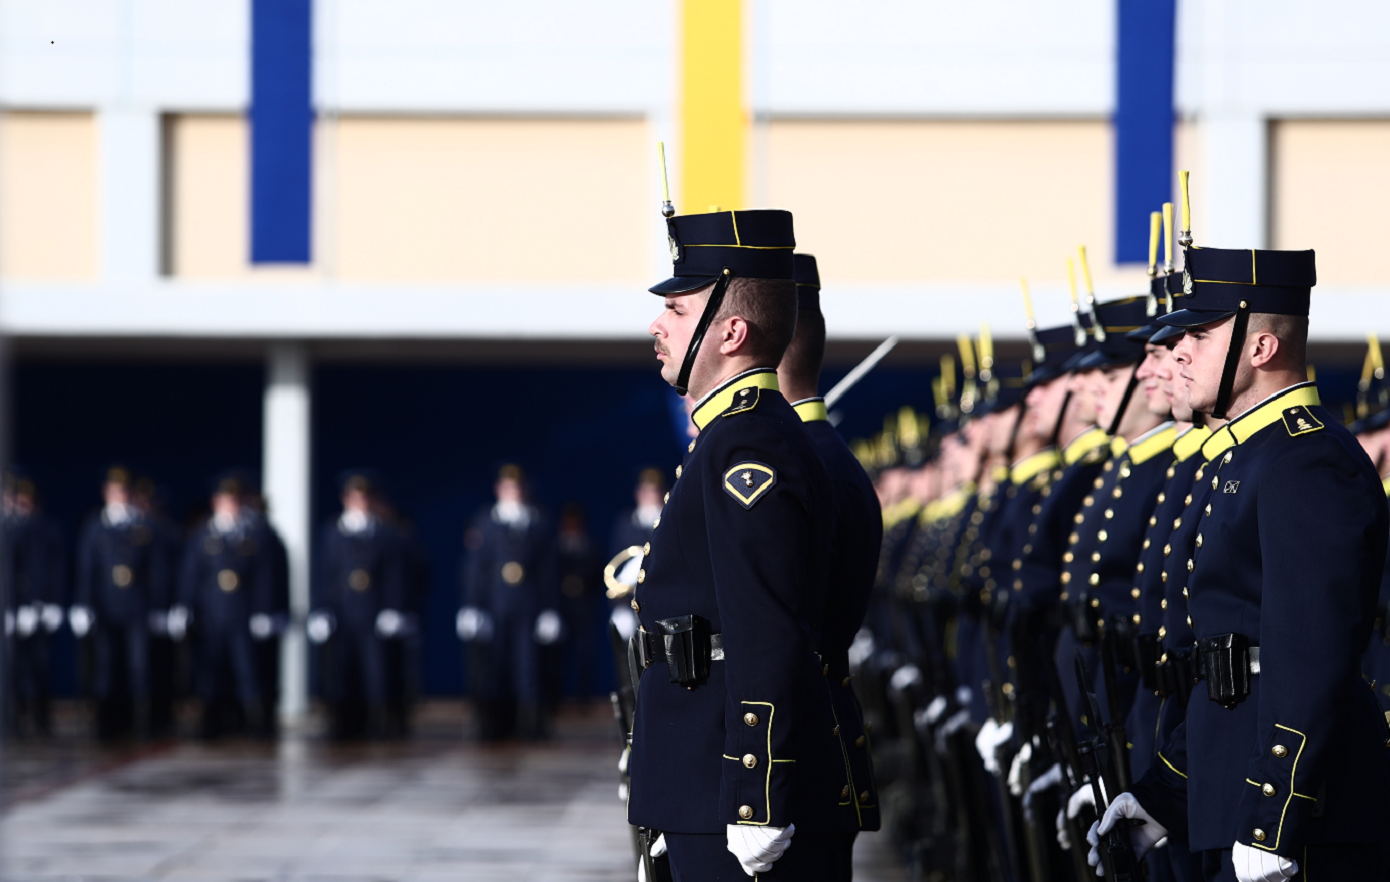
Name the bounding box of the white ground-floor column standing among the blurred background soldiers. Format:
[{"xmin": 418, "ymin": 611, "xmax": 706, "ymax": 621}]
[{"xmin": 263, "ymin": 343, "xmax": 313, "ymax": 724}]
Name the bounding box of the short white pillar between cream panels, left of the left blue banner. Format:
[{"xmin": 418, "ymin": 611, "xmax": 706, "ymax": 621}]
[{"xmin": 97, "ymin": 103, "xmax": 161, "ymax": 286}]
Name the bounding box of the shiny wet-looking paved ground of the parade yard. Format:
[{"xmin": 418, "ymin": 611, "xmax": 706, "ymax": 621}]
[{"xmin": 0, "ymin": 706, "xmax": 902, "ymax": 882}]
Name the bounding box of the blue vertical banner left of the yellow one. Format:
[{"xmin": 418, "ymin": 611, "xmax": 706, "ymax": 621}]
[{"xmin": 250, "ymin": 0, "xmax": 314, "ymax": 264}]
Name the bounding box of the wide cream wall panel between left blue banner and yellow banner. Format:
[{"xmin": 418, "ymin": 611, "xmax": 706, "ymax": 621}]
[{"xmin": 332, "ymin": 117, "xmax": 657, "ymax": 282}]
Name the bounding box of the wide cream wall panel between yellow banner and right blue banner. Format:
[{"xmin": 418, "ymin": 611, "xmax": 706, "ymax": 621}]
[{"xmin": 769, "ymin": 121, "xmax": 1119, "ymax": 283}]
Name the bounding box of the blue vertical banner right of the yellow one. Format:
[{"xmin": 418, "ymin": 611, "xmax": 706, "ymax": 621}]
[{"xmin": 1115, "ymin": 0, "xmax": 1176, "ymax": 264}]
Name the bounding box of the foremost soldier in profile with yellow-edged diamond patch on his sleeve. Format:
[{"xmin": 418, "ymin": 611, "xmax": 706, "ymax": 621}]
[{"xmin": 628, "ymin": 210, "xmax": 839, "ymax": 882}]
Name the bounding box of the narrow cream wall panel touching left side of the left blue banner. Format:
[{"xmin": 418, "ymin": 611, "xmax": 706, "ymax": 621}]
[{"xmin": 164, "ymin": 115, "xmax": 250, "ymax": 278}]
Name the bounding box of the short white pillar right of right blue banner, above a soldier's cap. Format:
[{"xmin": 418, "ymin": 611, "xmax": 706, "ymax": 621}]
[{"xmin": 1197, "ymin": 111, "xmax": 1269, "ymax": 249}]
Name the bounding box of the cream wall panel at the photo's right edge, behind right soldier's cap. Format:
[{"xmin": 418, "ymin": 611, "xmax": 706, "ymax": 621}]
[{"xmin": 1269, "ymin": 119, "xmax": 1390, "ymax": 285}]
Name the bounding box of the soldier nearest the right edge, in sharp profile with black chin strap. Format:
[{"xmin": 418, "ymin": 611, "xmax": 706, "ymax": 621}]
[{"xmin": 1093, "ymin": 194, "xmax": 1390, "ymax": 882}]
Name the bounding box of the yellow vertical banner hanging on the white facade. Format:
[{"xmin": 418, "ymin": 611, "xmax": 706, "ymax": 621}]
[{"xmin": 677, "ymin": 0, "xmax": 748, "ymax": 214}]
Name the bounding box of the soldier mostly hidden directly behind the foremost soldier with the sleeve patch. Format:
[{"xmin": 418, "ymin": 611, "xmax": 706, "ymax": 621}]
[{"xmin": 777, "ymin": 254, "xmax": 883, "ymax": 879}]
